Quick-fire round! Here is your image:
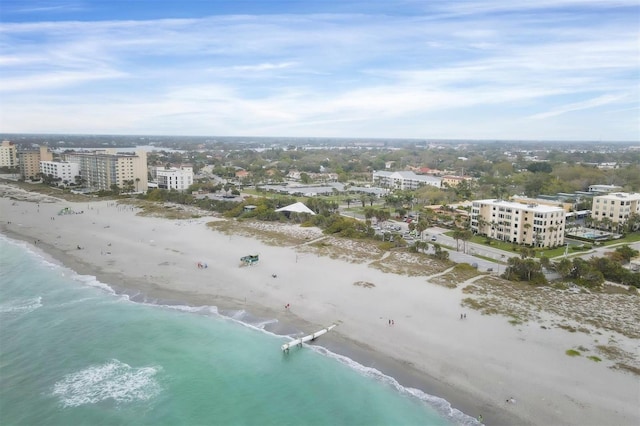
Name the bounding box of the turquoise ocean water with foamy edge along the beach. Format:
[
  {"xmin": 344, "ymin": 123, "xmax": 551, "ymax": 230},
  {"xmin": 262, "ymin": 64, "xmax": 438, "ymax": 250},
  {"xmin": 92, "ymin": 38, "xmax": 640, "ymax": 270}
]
[{"xmin": 0, "ymin": 236, "xmax": 475, "ymax": 425}]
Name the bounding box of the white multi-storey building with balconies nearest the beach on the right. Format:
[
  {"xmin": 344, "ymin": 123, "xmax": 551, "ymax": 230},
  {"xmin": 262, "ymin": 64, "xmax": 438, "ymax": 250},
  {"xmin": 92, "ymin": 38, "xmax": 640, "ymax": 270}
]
[{"xmin": 471, "ymin": 200, "xmax": 565, "ymax": 247}]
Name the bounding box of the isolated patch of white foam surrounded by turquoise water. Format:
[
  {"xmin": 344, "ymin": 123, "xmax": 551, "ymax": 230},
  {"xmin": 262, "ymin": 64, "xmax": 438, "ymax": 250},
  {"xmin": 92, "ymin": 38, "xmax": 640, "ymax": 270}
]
[{"xmin": 52, "ymin": 359, "xmax": 162, "ymax": 407}]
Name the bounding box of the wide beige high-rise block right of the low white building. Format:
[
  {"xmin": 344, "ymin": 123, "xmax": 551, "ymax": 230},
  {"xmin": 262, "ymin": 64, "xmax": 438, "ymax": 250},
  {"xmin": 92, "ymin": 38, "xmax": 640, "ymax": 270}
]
[{"xmin": 63, "ymin": 149, "xmax": 148, "ymax": 192}]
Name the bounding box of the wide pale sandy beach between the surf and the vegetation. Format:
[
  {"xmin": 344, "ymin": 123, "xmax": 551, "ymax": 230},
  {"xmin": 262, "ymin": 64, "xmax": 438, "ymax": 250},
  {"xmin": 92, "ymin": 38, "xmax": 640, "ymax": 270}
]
[{"xmin": 0, "ymin": 185, "xmax": 640, "ymax": 425}]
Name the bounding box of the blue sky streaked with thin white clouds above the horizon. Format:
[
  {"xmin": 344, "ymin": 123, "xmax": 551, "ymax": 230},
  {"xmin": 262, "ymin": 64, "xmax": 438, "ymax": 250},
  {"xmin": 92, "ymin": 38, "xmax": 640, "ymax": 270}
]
[{"xmin": 0, "ymin": 0, "xmax": 640, "ymax": 141}]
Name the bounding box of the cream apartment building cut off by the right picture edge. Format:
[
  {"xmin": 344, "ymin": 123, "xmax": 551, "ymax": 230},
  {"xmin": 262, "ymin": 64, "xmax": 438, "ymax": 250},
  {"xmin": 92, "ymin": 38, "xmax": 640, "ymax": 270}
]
[{"xmin": 591, "ymin": 192, "xmax": 640, "ymax": 227}]
